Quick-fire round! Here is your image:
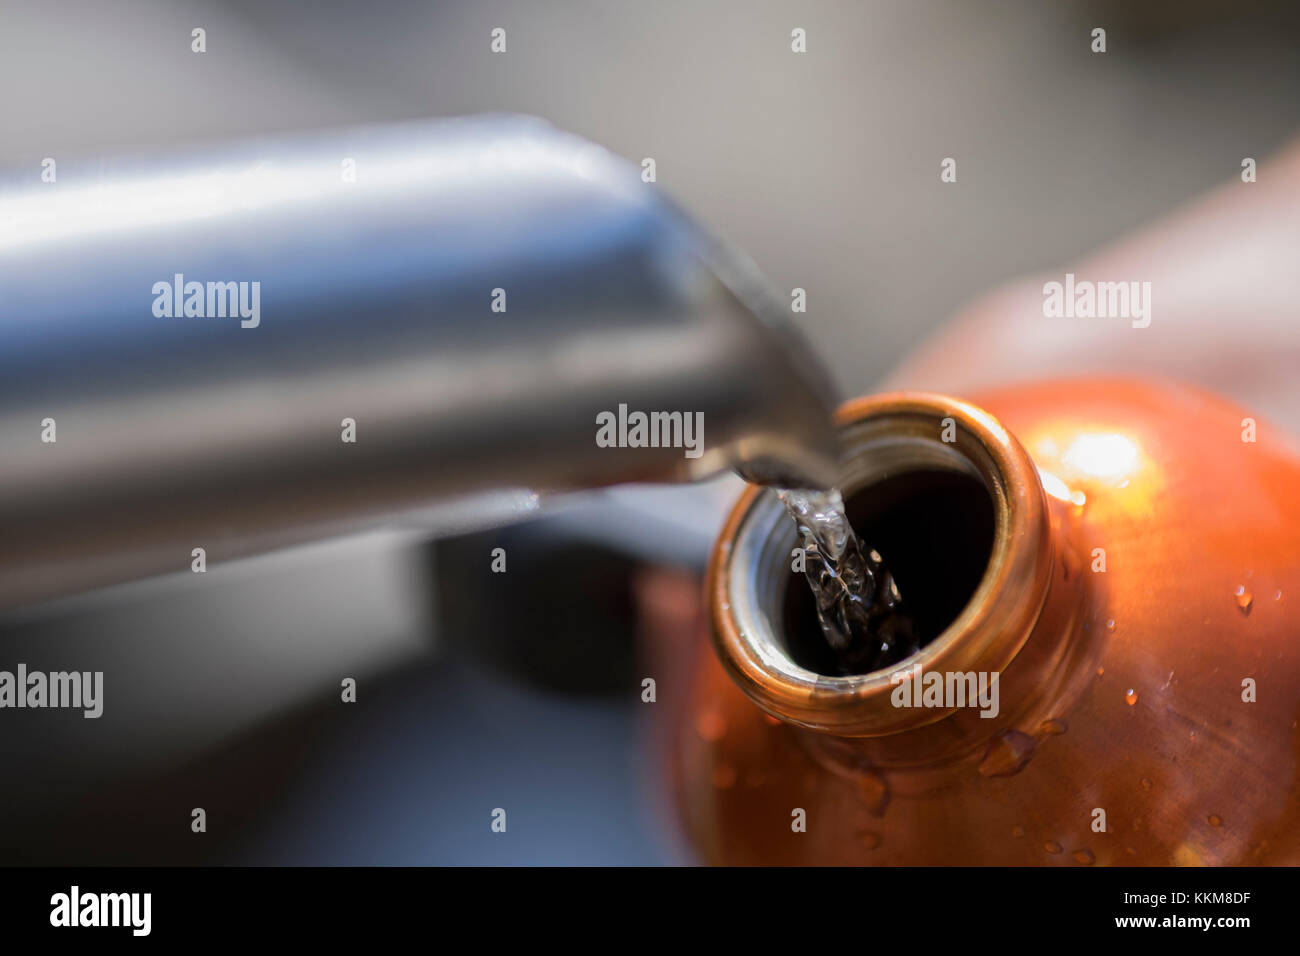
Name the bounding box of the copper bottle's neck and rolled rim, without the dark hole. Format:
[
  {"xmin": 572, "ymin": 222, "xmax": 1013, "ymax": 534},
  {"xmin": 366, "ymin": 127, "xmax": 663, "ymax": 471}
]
[{"xmin": 709, "ymin": 393, "xmax": 1083, "ymax": 770}]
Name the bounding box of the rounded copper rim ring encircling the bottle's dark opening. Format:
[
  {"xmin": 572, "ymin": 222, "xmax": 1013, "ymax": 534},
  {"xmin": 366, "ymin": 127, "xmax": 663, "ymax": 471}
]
[{"xmin": 706, "ymin": 392, "xmax": 1053, "ymax": 736}]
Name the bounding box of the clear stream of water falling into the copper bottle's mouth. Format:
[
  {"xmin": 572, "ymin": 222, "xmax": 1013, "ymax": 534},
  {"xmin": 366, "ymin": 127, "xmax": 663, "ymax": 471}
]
[{"xmin": 776, "ymin": 488, "xmax": 920, "ymax": 675}]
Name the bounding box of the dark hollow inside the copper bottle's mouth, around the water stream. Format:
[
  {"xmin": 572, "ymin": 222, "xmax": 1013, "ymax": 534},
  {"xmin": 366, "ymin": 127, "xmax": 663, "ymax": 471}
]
[{"xmin": 779, "ymin": 468, "xmax": 995, "ymax": 675}]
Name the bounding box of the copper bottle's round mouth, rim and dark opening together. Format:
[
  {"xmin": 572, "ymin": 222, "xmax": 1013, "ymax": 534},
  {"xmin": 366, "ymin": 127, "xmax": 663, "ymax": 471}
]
[{"xmin": 709, "ymin": 393, "xmax": 1053, "ymax": 736}]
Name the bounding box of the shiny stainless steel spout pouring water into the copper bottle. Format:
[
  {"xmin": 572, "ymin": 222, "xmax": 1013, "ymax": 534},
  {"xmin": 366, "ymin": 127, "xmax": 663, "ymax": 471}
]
[{"xmin": 0, "ymin": 111, "xmax": 836, "ymax": 607}]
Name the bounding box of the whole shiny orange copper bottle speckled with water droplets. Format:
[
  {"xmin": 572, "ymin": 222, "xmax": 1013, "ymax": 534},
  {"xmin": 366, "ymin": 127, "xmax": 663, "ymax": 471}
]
[{"xmin": 672, "ymin": 381, "xmax": 1300, "ymax": 866}]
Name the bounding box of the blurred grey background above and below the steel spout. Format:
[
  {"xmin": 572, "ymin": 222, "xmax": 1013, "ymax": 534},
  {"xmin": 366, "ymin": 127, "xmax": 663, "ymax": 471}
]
[{"xmin": 0, "ymin": 0, "xmax": 1300, "ymax": 864}]
